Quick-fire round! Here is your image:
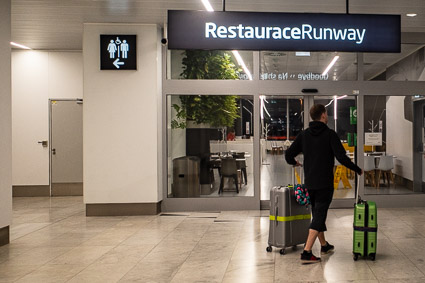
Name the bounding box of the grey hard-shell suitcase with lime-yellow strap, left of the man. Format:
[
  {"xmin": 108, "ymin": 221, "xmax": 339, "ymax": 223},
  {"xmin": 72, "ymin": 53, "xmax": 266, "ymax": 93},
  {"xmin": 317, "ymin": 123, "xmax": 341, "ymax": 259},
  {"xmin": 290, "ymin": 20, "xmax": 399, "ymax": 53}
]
[{"xmin": 266, "ymin": 168, "xmax": 311, "ymax": 254}]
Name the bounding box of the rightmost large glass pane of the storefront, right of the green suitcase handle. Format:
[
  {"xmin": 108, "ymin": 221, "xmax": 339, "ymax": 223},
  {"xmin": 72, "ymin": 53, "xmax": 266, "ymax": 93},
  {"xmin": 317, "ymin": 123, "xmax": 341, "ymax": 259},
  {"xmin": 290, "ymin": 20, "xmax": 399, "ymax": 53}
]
[{"xmin": 364, "ymin": 96, "xmax": 425, "ymax": 195}]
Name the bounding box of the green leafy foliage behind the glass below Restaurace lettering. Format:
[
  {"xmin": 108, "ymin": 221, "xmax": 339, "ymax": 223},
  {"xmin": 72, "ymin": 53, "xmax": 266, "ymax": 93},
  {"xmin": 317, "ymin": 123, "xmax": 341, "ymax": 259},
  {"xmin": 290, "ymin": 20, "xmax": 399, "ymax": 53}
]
[{"xmin": 171, "ymin": 50, "xmax": 240, "ymax": 129}]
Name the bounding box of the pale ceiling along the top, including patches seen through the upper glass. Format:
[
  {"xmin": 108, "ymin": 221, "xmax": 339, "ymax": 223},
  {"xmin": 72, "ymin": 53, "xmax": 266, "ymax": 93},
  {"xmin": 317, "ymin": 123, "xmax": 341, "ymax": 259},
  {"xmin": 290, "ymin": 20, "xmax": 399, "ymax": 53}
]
[{"xmin": 11, "ymin": 0, "xmax": 425, "ymax": 79}]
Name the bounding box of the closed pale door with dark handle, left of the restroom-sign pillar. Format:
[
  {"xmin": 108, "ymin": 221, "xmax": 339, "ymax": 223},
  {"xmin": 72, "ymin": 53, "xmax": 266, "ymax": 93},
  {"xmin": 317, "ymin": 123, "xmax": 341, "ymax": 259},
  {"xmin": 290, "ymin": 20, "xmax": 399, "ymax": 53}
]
[{"xmin": 50, "ymin": 100, "xmax": 83, "ymax": 196}]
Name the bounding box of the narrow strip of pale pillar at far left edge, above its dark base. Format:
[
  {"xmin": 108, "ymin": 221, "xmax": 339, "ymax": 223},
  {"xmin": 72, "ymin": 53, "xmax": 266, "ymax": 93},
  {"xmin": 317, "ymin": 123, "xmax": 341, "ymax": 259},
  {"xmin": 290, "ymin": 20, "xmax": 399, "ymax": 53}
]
[{"xmin": 0, "ymin": 0, "xmax": 12, "ymax": 228}]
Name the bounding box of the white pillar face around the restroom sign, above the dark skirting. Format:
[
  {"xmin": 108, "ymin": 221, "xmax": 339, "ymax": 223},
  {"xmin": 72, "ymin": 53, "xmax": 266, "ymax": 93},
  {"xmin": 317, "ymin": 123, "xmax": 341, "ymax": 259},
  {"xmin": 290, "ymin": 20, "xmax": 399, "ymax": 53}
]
[{"xmin": 83, "ymin": 24, "xmax": 162, "ymax": 203}]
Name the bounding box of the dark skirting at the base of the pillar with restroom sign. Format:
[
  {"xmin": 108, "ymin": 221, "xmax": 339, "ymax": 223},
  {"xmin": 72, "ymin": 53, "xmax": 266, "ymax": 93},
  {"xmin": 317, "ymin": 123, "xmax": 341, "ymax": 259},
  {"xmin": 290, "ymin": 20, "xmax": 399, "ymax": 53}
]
[{"xmin": 86, "ymin": 202, "xmax": 161, "ymax": 216}]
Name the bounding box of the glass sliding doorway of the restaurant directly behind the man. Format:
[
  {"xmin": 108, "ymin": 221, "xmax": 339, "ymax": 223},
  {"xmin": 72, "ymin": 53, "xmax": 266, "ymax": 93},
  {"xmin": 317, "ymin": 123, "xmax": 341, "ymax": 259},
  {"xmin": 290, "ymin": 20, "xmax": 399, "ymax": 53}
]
[{"xmin": 260, "ymin": 95, "xmax": 357, "ymax": 207}]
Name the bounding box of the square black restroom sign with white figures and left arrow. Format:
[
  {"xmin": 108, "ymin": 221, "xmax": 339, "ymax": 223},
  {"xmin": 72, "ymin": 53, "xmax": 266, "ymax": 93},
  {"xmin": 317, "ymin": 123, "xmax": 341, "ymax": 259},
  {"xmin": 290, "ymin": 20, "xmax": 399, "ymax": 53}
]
[{"xmin": 100, "ymin": 34, "xmax": 137, "ymax": 70}]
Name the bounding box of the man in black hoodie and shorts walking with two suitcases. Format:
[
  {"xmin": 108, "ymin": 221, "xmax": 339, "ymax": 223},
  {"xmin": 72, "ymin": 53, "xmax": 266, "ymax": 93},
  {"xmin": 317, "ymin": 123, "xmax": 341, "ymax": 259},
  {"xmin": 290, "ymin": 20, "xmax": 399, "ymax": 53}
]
[{"xmin": 285, "ymin": 104, "xmax": 363, "ymax": 264}]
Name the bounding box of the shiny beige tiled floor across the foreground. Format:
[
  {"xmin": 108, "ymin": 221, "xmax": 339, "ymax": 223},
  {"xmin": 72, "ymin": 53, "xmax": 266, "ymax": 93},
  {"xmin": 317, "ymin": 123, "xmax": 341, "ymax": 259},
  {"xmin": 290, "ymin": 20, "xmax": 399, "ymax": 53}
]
[{"xmin": 0, "ymin": 197, "xmax": 425, "ymax": 283}]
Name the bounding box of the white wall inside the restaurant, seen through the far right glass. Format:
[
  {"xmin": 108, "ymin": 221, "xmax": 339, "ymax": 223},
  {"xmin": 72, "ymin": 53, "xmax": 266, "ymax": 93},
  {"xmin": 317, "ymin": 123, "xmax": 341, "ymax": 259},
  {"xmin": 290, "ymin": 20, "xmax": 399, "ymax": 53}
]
[{"xmin": 385, "ymin": 96, "xmax": 413, "ymax": 180}]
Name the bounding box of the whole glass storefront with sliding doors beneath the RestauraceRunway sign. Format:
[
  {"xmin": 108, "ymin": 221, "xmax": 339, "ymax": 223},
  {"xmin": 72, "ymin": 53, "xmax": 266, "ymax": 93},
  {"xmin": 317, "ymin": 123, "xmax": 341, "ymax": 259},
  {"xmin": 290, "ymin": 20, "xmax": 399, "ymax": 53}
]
[{"xmin": 164, "ymin": 45, "xmax": 425, "ymax": 209}]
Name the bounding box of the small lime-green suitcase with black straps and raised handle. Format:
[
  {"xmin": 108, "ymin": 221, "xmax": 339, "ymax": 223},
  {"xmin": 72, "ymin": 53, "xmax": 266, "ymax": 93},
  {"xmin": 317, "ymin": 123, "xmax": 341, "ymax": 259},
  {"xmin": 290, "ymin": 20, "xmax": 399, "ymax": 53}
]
[{"xmin": 353, "ymin": 177, "xmax": 378, "ymax": 260}]
